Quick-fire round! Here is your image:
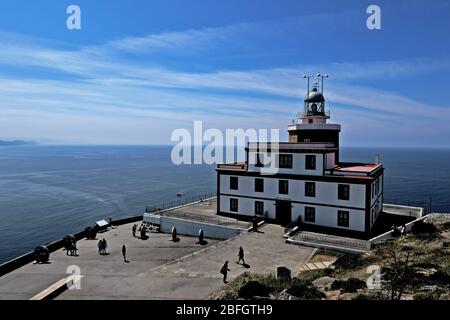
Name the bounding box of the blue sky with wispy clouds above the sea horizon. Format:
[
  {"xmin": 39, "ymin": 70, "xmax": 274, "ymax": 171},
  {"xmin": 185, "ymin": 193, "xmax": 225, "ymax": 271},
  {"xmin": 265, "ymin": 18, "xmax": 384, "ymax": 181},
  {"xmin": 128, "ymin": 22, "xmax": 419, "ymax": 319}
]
[{"xmin": 0, "ymin": 0, "xmax": 450, "ymax": 147}]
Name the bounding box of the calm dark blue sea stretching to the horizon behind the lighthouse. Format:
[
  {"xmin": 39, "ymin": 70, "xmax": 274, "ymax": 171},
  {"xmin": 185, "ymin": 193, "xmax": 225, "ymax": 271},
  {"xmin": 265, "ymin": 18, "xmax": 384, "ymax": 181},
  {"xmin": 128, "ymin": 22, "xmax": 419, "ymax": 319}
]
[{"xmin": 0, "ymin": 146, "xmax": 450, "ymax": 263}]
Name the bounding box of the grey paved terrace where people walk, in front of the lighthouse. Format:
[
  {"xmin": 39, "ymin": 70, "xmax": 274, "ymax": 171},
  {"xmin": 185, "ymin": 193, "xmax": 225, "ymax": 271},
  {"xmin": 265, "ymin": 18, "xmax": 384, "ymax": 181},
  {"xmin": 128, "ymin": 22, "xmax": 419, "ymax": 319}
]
[{"xmin": 0, "ymin": 203, "xmax": 313, "ymax": 299}]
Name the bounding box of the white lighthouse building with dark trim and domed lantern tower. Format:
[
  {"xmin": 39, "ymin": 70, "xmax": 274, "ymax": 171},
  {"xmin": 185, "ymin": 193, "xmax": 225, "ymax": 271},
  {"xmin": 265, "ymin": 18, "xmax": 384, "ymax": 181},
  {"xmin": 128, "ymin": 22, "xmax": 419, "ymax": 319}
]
[{"xmin": 216, "ymin": 80, "xmax": 384, "ymax": 238}]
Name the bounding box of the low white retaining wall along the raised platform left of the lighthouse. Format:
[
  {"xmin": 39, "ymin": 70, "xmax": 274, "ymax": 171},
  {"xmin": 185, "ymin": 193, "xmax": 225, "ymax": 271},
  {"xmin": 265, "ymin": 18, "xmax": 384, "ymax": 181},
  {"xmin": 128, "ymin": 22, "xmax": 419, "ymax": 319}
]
[{"xmin": 144, "ymin": 213, "xmax": 247, "ymax": 240}]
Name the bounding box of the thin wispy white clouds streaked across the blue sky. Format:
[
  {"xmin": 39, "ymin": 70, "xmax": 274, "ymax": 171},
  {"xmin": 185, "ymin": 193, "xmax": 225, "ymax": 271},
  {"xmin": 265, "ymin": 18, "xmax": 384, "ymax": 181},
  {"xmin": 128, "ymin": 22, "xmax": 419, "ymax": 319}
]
[{"xmin": 0, "ymin": 26, "xmax": 450, "ymax": 146}]
